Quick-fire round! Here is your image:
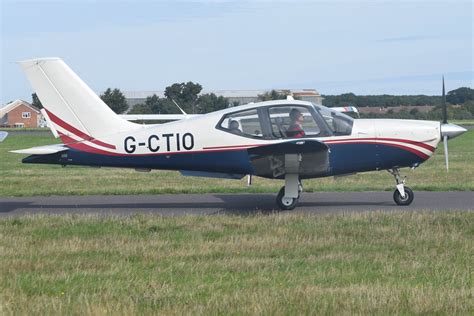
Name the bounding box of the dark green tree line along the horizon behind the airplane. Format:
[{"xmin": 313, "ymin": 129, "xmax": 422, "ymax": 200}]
[{"xmin": 32, "ymin": 86, "xmax": 474, "ymax": 120}]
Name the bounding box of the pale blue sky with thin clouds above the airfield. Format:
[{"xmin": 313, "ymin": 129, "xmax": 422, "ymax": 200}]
[{"xmin": 0, "ymin": 0, "xmax": 474, "ymax": 104}]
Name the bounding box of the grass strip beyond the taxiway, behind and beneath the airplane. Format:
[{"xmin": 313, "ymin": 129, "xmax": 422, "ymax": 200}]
[{"xmin": 0, "ymin": 130, "xmax": 474, "ymax": 196}]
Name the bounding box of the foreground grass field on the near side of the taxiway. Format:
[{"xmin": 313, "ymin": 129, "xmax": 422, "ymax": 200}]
[{"xmin": 0, "ymin": 212, "xmax": 474, "ymax": 315}]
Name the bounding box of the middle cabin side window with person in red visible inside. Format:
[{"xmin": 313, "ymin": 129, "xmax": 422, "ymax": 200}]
[{"xmin": 268, "ymin": 106, "xmax": 321, "ymax": 138}]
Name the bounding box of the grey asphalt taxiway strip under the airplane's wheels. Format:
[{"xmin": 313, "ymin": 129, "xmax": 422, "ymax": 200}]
[{"xmin": 0, "ymin": 191, "xmax": 474, "ymax": 217}]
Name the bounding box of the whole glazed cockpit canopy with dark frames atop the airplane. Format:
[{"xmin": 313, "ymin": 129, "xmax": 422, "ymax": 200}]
[{"xmin": 216, "ymin": 104, "xmax": 354, "ymax": 139}]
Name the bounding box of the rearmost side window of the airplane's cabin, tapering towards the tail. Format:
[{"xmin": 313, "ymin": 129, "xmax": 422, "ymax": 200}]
[{"xmin": 219, "ymin": 109, "xmax": 263, "ymax": 138}]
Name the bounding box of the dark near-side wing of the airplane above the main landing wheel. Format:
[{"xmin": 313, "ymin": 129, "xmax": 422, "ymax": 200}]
[{"xmin": 248, "ymin": 140, "xmax": 330, "ymax": 179}]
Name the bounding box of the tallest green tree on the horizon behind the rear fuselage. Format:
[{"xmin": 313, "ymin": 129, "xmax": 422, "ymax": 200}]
[{"xmin": 165, "ymin": 81, "xmax": 202, "ymax": 113}]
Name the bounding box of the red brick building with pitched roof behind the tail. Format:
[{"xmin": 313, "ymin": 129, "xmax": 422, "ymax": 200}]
[{"xmin": 0, "ymin": 100, "xmax": 46, "ymax": 128}]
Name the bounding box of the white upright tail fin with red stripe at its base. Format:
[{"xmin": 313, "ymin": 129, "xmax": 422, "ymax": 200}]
[{"xmin": 19, "ymin": 58, "xmax": 138, "ymax": 140}]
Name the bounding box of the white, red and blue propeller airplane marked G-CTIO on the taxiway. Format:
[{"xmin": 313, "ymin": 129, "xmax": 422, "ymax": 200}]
[{"xmin": 13, "ymin": 58, "xmax": 466, "ymax": 210}]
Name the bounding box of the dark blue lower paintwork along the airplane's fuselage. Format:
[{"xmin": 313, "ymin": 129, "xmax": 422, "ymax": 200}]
[{"xmin": 39, "ymin": 143, "xmax": 423, "ymax": 176}]
